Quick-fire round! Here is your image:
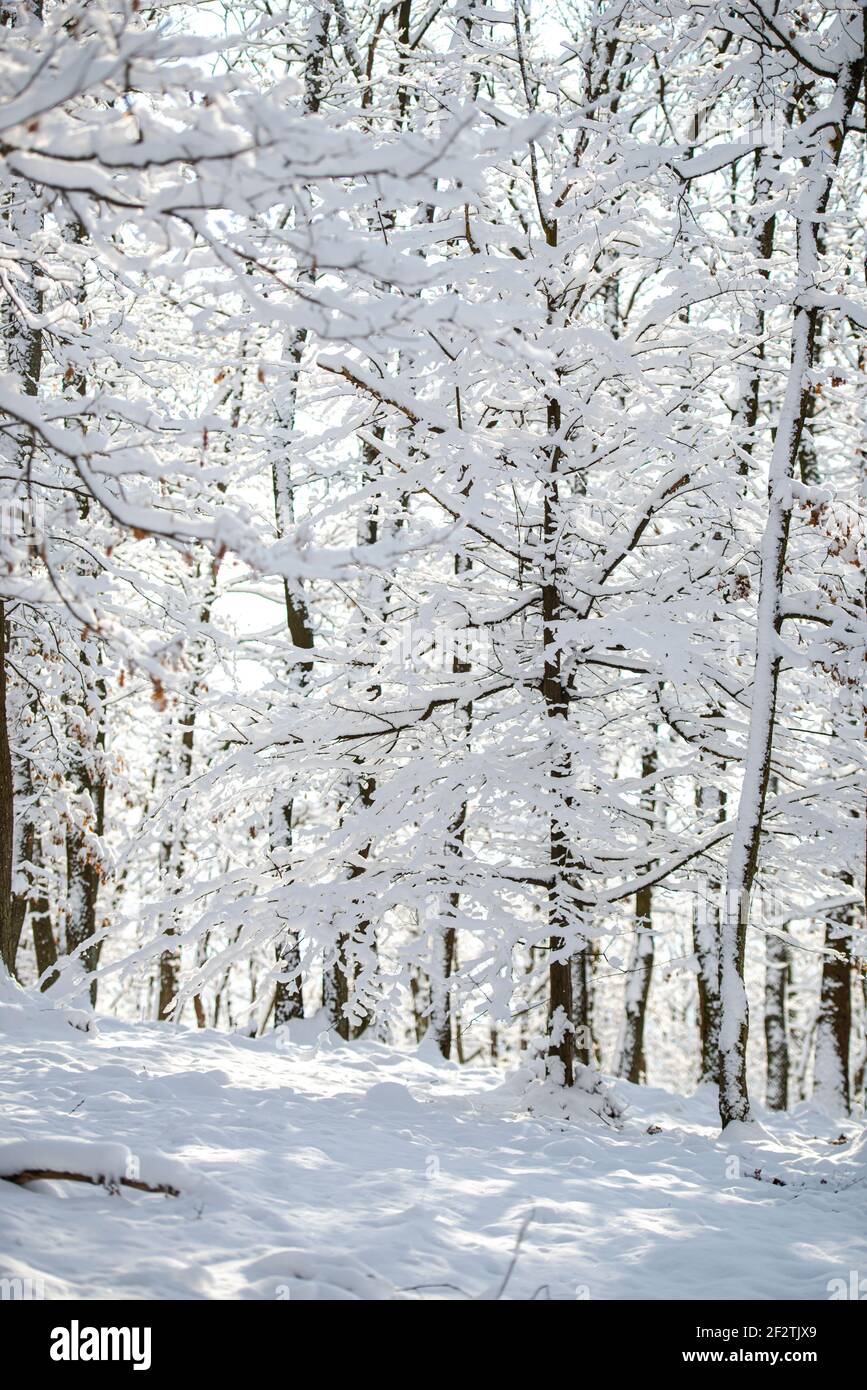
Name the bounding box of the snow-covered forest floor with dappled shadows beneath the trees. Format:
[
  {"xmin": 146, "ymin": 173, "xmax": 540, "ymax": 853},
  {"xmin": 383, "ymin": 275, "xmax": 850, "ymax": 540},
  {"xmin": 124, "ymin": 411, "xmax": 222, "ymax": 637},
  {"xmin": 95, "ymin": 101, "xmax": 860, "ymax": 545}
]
[{"xmin": 0, "ymin": 992, "xmax": 867, "ymax": 1300}]
